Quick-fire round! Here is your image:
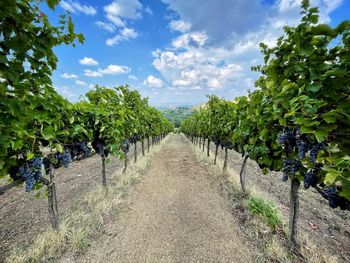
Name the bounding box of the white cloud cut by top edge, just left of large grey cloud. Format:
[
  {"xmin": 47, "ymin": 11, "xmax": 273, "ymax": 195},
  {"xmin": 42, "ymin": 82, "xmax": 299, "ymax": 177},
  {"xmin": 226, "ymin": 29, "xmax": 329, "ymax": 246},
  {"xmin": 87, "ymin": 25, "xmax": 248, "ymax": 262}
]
[{"xmin": 104, "ymin": 0, "xmax": 142, "ymax": 27}]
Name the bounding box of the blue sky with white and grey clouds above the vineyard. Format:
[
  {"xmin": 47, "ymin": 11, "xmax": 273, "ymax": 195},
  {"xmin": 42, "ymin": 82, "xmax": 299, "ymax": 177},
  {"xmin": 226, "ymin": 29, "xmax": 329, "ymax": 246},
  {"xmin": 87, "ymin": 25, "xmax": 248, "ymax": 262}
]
[{"xmin": 47, "ymin": 0, "xmax": 350, "ymax": 107}]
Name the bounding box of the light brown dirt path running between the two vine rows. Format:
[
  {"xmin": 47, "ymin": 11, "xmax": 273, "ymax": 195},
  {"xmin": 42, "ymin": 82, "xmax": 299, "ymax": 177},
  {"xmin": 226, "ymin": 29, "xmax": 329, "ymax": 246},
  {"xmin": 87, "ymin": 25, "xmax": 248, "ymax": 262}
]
[{"xmin": 74, "ymin": 135, "xmax": 252, "ymax": 263}]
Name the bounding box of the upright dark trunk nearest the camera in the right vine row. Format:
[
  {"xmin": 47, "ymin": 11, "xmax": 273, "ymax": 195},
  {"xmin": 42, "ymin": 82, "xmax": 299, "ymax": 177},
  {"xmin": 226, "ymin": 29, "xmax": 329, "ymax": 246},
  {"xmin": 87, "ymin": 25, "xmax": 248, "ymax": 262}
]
[{"xmin": 289, "ymin": 179, "xmax": 300, "ymax": 249}]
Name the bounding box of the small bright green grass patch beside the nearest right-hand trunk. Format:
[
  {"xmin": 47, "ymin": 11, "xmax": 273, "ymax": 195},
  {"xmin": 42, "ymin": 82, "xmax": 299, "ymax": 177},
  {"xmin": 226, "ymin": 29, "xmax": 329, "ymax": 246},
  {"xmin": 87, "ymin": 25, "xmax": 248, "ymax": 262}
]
[{"xmin": 247, "ymin": 196, "xmax": 282, "ymax": 229}]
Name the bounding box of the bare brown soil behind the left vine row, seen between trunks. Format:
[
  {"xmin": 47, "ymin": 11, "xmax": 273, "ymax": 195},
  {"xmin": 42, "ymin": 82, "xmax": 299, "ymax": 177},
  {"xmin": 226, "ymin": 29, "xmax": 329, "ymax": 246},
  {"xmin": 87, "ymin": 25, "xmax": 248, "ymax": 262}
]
[{"xmin": 0, "ymin": 143, "xmax": 146, "ymax": 262}]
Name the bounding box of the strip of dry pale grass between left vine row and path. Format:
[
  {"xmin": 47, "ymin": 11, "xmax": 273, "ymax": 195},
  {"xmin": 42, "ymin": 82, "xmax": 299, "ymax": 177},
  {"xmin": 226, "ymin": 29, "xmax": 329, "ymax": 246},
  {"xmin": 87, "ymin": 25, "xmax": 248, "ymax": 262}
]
[{"xmin": 6, "ymin": 138, "xmax": 168, "ymax": 263}]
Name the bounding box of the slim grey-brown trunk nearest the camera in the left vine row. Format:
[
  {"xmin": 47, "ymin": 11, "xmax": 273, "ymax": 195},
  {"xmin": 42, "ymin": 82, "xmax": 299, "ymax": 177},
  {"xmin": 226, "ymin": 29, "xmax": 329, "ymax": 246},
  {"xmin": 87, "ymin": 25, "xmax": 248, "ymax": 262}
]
[{"xmin": 47, "ymin": 164, "xmax": 59, "ymax": 230}]
